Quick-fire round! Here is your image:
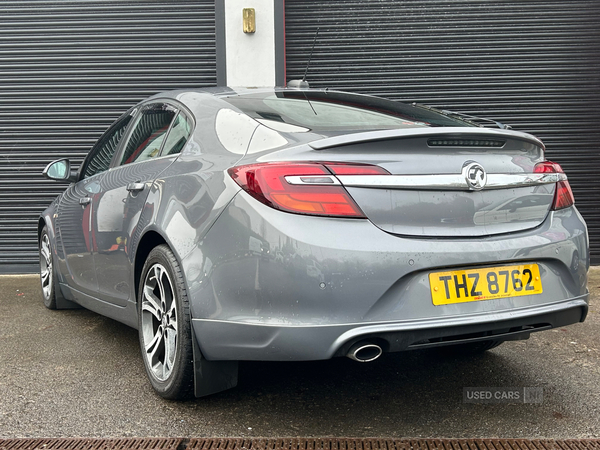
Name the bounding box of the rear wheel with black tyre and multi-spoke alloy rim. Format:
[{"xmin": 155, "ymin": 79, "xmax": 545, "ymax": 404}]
[{"xmin": 138, "ymin": 245, "xmax": 194, "ymax": 400}]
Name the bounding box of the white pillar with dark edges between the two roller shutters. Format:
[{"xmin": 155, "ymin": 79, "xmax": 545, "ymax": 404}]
[{"xmin": 215, "ymin": 0, "xmax": 285, "ymax": 87}]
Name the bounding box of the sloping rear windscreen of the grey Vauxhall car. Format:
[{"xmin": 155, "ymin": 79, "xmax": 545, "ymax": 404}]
[{"xmin": 223, "ymin": 91, "xmax": 473, "ymax": 132}]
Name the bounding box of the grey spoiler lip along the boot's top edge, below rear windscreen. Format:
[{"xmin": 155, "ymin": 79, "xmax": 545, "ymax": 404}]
[{"xmin": 308, "ymin": 127, "xmax": 545, "ymax": 150}]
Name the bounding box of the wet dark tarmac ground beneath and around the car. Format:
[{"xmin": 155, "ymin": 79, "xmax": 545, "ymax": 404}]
[{"xmin": 0, "ymin": 267, "xmax": 600, "ymax": 438}]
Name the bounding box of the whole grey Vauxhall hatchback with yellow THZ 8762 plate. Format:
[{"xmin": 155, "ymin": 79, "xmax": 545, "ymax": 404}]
[{"xmin": 39, "ymin": 88, "xmax": 589, "ymax": 399}]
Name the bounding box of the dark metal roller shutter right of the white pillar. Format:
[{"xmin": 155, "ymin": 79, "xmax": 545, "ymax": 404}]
[{"xmin": 285, "ymin": 0, "xmax": 600, "ymax": 263}]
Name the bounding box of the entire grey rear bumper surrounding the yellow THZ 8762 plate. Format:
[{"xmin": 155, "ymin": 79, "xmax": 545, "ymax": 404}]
[{"xmin": 182, "ymin": 193, "xmax": 589, "ymax": 361}]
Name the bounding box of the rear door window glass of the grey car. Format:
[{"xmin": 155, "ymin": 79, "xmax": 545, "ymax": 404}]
[{"xmin": 120, "ymin": 103, "xmax": 177, "ymax": 165}]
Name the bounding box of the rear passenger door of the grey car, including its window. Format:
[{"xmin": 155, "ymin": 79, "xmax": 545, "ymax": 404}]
[{"xmin": 92, "ymin": 101, "xmax": 191, "ymax": 306}]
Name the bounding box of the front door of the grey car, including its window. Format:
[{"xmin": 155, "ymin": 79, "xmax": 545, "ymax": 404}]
[{"xmin": 57, "ymin": 111, "xmax": 134, "ymax": 296}]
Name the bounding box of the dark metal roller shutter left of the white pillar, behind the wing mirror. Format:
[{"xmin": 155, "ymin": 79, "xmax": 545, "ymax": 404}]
[{"xmin": 0, "ymin": 0, "xmax": 216, "ymax": 273}]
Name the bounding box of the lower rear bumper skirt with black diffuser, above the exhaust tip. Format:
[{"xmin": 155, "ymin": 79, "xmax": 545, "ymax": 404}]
[{"xmin": 192, "ymin": 294, "xmax": 589, "ymax": 361}]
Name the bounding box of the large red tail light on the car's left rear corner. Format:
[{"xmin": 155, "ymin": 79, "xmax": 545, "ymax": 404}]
[{"xmin": 228, "ymin": 163, "xmax": 389, "ymax": 218}]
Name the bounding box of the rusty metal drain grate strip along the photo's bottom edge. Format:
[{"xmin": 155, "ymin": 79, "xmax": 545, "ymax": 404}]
[{"xmin": 0, "ymin": 438, "xmax": 600, "ymax": 450}]
